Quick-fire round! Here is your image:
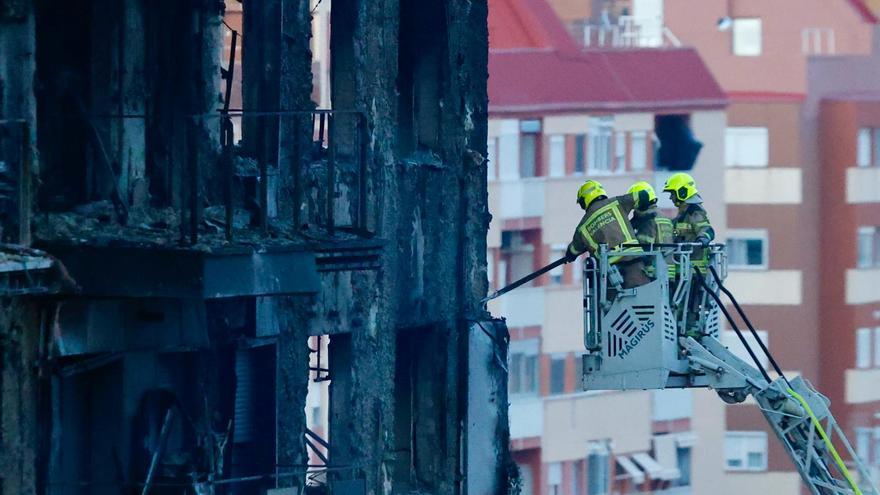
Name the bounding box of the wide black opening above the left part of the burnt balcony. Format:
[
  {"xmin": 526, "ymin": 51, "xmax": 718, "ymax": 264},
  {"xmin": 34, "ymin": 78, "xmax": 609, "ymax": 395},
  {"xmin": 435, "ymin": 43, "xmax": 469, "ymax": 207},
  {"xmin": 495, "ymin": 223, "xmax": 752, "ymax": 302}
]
[{"xmin": 34, "ymin": 0, "xmax": 213, "ymax": 213}]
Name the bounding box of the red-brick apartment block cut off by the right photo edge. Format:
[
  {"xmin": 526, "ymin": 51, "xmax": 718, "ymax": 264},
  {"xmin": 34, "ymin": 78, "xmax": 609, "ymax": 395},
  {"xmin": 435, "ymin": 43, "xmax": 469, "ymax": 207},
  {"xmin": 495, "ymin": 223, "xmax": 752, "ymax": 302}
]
[{"xmin": 803, "ymin": 41, "xmax": 880, "ymax": 480}]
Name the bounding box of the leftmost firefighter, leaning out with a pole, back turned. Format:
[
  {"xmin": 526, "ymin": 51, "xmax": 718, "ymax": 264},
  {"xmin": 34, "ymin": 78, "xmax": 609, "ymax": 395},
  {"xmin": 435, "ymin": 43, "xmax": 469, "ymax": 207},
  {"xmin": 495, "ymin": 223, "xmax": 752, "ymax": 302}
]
[{"xmin": 566, "ymin": 180, "xmax": 650, "ymax": 290}]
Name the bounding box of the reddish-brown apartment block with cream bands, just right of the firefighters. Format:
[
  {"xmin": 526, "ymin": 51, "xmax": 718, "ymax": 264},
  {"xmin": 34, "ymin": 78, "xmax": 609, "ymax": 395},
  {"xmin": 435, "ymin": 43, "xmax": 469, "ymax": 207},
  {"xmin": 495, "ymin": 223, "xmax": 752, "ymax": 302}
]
[{"xmin": 663, "ymin": 0, "xmax": 876, "ymax": 493}]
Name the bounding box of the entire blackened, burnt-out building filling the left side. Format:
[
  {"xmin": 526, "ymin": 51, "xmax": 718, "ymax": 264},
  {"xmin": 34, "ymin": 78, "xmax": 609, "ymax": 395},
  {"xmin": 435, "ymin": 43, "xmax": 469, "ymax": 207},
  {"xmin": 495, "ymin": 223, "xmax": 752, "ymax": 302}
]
[{"xmin": 0, "ymin": 0, "xmax": 510, "ymax": 495}]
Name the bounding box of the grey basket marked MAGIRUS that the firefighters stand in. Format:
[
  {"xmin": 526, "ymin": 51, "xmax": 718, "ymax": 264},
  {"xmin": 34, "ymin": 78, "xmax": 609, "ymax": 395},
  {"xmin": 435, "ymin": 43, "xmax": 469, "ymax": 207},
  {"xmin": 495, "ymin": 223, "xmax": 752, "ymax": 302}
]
[{"xmin": 583, "ymin": 244, "xmax": 727, "ymax": 390}]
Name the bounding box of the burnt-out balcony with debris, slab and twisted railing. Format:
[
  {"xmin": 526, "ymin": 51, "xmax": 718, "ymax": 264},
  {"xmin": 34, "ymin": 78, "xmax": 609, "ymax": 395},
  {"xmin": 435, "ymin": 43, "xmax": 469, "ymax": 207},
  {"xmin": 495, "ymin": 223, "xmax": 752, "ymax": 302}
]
[{"xmin": 20, "ymin": 109, "xmax": 382, "ymax": 299}]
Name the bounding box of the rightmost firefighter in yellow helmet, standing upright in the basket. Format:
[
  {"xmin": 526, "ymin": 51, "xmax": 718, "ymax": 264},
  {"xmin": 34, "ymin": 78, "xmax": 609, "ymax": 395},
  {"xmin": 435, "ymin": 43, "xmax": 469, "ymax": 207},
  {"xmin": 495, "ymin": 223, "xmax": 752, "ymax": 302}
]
[{"xmin": 663, "ymin": 172, "xmax": 715, "ymax": 338}]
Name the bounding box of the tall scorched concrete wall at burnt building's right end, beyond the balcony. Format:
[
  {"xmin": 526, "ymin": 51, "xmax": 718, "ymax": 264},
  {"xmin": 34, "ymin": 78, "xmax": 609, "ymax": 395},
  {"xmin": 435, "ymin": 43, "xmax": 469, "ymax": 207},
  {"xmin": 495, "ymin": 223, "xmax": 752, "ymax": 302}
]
[{"xmin": 317, "ymin": 0, "xmax": 507, "ymax": 493}]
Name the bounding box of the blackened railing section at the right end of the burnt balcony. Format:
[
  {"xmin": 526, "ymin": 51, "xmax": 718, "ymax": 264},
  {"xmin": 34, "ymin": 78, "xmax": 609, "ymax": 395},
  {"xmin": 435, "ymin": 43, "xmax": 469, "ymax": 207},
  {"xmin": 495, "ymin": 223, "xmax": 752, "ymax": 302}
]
[{"xmin": 187, "ymin": 109, "xmax": 369, "ymax": 243}]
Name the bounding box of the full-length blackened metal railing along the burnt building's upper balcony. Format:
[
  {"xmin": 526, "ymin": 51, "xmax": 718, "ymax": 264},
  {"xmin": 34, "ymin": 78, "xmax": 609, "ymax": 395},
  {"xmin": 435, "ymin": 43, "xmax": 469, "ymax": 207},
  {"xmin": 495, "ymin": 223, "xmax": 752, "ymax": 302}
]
[{"xmin": 20, "ymin": 106, "xmax": 370, "ymax": 245}]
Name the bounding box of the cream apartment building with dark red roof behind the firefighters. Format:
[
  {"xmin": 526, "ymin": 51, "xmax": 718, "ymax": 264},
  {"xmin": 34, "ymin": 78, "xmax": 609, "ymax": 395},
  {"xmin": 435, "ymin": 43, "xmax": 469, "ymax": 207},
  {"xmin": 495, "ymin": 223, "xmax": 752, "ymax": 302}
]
[{"xmin": 488, "ymin": 0, "xmax": 726, "ymax": 495}]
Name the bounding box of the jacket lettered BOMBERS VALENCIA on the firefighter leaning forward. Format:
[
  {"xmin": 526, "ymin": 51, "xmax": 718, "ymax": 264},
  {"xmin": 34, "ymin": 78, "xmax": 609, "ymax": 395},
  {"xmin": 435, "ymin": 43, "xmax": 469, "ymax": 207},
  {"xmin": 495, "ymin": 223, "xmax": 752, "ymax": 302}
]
[{"xmin": 568, "ymin": 195, "xmax": 642, "ymax": 264}]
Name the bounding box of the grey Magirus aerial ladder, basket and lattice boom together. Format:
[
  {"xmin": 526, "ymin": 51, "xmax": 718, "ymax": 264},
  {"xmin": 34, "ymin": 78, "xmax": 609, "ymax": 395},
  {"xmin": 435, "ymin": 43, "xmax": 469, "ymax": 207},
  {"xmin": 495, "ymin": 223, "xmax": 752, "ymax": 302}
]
[{"xmin": 483, "ymin": 244, "xmax": 880, "ymax": 495}]
